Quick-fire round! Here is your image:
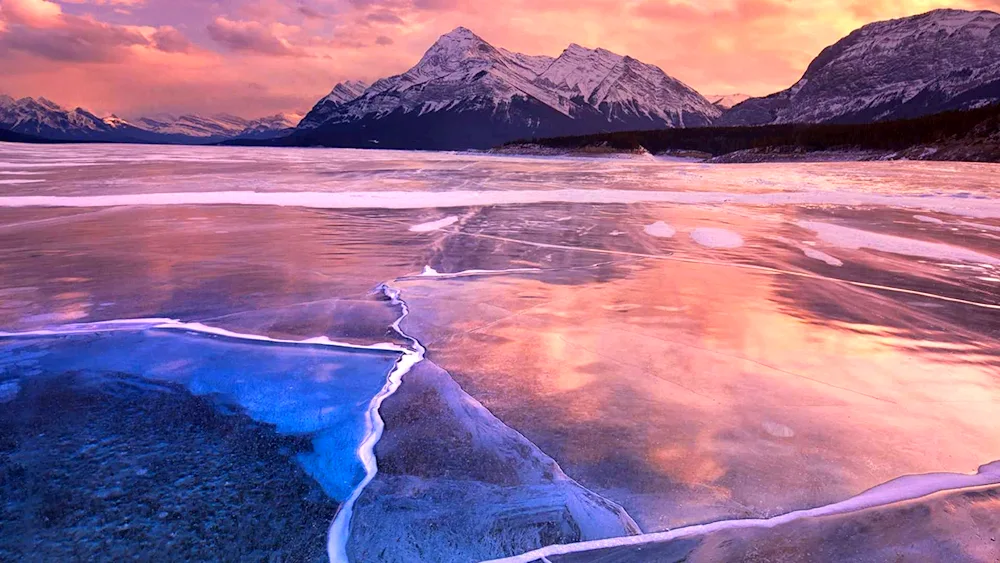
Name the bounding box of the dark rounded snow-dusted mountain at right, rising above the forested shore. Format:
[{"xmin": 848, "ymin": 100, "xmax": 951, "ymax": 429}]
[{"xmin": 718, "ymin": 10, "xmax": 1000, "ymax": 125}]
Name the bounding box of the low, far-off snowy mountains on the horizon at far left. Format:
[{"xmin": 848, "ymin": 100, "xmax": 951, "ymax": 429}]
[{"xmin": 0, "ymin": 95, "xmax": 295, "ymax": 143}]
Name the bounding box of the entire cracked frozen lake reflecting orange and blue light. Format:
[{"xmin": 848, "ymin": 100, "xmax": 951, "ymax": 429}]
[{"xmin": 0, "ymin": 144, "xmax": 1000, "ymax": 563}]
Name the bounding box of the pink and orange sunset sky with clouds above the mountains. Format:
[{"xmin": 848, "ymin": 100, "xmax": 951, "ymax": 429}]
[{"xmin": 0, "ymin": 0, "xmax": 1000, "ymax": 118}]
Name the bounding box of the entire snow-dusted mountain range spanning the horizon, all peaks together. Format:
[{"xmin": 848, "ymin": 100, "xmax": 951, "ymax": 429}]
[{"xmin": 0, "ymin": 10, "xmax": 1000, "ymax": 149}]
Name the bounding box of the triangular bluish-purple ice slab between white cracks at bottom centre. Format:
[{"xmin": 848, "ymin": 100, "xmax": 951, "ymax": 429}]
[{"xmin": 348, "ymin": 362, "xmax": 639, "ymax": 563}]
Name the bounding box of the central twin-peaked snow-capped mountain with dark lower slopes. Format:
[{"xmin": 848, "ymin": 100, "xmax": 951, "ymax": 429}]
[{"xmin": 289, "ymin": 27, "xmax": 722, "ymax": 149}]
